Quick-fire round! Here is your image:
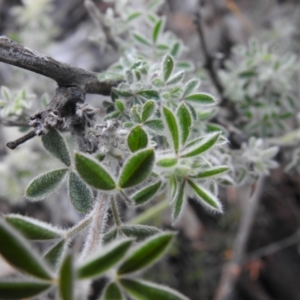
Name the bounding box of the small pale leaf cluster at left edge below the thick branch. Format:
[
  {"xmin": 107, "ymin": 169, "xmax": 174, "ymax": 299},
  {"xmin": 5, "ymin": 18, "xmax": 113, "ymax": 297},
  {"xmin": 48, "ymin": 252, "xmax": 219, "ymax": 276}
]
[{"xmin": 0, "ymin": 86, "xmax": 35, "ymax": 121}]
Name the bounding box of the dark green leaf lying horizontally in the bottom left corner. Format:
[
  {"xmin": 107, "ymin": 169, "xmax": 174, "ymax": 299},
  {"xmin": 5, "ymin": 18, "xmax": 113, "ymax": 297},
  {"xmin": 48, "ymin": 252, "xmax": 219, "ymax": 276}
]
[{"xmin": 0, "ymin": 279, "xmax": 51, "ymax": 300}]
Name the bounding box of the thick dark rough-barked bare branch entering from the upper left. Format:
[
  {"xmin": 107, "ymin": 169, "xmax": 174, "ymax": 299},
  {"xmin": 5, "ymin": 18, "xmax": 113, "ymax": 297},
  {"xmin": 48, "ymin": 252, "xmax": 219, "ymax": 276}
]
[{"xmin": 0, "ymin": 36, "xmax": 120, "ymax": 95}]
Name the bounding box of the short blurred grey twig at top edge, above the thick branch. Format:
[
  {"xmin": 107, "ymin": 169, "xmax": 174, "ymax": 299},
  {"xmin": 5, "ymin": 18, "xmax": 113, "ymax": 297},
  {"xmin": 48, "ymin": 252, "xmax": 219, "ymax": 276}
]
[{"xmin": 84, "ymin": 0, "xmax": 119, "ymax": 51}]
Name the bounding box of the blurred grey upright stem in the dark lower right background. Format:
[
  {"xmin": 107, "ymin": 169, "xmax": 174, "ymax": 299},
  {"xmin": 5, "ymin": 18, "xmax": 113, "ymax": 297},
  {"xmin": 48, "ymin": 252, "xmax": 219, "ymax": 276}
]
[{"xmin": 214, "ymin": 178, "xmax": 264, "ymax": 300}]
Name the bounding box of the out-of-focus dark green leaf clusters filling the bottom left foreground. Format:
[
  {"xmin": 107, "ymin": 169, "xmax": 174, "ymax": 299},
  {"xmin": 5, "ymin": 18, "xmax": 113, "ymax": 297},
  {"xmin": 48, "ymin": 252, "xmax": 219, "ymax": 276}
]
[{"xmin": 0, "ymin": 214, "xmax": 187, "ymax": 300}]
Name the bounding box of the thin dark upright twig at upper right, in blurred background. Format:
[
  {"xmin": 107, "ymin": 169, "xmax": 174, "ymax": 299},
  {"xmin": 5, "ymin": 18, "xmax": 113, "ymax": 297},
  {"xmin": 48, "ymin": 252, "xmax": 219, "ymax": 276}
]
[{"xmin": 195, "ymin": 8, "xmax": 225, "ymax": 101}]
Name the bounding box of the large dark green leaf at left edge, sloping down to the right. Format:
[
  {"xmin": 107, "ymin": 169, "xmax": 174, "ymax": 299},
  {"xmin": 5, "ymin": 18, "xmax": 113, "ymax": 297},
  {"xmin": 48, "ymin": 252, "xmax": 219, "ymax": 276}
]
[{"xmin": 0, "ymin": 219, "xmax": 52, "ymax": 280}]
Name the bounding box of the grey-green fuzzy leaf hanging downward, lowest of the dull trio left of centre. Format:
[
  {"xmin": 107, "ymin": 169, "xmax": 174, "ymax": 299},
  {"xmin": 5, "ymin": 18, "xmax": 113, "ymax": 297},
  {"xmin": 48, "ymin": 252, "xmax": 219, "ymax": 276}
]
[{"xmin": 68, "ymin": 171, "xmax": 94, "ymax": 213}]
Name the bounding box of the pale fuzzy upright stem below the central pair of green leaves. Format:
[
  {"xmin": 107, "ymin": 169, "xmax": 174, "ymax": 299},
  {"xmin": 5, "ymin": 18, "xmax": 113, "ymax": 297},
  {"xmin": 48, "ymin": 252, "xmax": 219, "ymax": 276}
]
[{"xmin": 81, "ymin": 193, "xmax": 109, "ymax": 259}]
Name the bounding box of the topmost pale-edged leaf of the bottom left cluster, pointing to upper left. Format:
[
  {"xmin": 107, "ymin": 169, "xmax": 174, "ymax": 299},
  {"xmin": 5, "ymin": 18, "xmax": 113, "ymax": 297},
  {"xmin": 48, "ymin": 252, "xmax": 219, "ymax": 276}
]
[{"xmin": 4, "ymin": 214, "xmax": 64, "ymax": 241}]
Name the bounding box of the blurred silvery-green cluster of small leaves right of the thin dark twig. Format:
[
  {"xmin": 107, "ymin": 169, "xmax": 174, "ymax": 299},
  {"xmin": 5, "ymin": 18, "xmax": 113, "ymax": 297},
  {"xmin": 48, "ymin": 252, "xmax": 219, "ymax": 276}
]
[{"xmin": 221, "ymin": 39, "xmax": 296, "ymax": 137}]
